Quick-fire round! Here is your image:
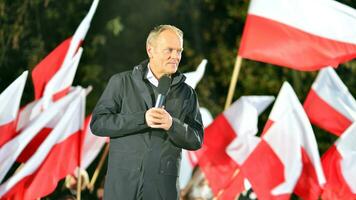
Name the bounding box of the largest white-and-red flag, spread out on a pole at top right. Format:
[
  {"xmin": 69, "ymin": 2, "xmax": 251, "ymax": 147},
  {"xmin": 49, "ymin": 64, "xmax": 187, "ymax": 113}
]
[{"xmin": 239, "ymin": 0, "xmax": 356, "ymax": 71}]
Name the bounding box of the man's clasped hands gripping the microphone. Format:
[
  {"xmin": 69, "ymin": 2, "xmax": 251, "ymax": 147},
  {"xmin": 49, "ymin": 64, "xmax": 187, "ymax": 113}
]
[{"xmin": 145, "ymin": 108, "xmax": 172, "ymax": 131}]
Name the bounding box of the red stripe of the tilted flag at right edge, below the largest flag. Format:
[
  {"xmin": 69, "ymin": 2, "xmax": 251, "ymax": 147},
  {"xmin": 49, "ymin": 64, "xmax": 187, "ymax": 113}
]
[{"xmin": 303, "ymin": 89, "xmax": 352, "ymax": 136}]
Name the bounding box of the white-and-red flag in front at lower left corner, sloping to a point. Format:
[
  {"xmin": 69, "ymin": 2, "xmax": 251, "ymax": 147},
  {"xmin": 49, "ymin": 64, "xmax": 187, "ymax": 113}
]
[{"xmin": 0, "ymin": 90, "xmax": 85, "ymax": 199}]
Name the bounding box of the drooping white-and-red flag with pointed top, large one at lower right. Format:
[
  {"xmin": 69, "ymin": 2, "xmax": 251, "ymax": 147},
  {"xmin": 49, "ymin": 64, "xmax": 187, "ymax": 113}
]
[{"xmin": 241, "ymin": 82, "xmax": 325, "ymax": 199}]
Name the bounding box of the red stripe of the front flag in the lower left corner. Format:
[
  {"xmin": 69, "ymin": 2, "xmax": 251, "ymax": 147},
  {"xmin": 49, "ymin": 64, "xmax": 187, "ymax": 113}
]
[{"xmin": 2, "ymin": 131, "xmax": 83, "ymax": 200}]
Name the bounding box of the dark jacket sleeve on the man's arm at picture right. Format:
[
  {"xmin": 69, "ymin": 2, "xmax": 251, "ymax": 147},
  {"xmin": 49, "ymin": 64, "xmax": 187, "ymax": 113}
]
[{"xmin": 168, "ymin": 89, "xmax": 204, "ymax": 150}]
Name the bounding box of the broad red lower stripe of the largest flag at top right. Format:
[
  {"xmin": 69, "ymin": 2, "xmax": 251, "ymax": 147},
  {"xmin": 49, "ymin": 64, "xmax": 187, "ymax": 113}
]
[{"xmin": 239, "ymin": 14, "xmax": 356, "ymax": 71}]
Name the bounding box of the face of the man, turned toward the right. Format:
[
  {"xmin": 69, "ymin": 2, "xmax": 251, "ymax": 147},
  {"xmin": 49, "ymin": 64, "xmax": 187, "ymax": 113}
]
[{"xmin": 147, "ymin": 30, "xmax": 183, "ymax": 78}]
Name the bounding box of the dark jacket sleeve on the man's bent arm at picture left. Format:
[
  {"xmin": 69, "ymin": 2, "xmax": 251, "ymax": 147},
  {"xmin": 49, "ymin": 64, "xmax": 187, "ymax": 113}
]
[{"xmin": 90, "ymin": 74, "xmax": 148, "ymax": 137}]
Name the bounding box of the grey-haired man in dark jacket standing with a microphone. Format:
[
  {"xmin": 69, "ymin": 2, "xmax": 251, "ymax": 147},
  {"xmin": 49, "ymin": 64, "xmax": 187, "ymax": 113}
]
[{"xmin": 91, "ymin": 25, "xmax": 203, "ymax": 200}]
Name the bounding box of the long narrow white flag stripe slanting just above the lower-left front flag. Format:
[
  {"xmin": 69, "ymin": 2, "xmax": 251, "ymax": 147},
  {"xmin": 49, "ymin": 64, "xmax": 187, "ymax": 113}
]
[{"xmin": 0, "ymin": 88, "xmax": 79, "ymax": 182}]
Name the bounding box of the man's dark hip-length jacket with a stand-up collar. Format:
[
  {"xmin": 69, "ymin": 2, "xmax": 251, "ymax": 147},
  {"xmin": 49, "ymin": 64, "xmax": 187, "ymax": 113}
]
[{"xmin": 90, "ymin": 62, "xmax": 203, "ymax": 200}]
